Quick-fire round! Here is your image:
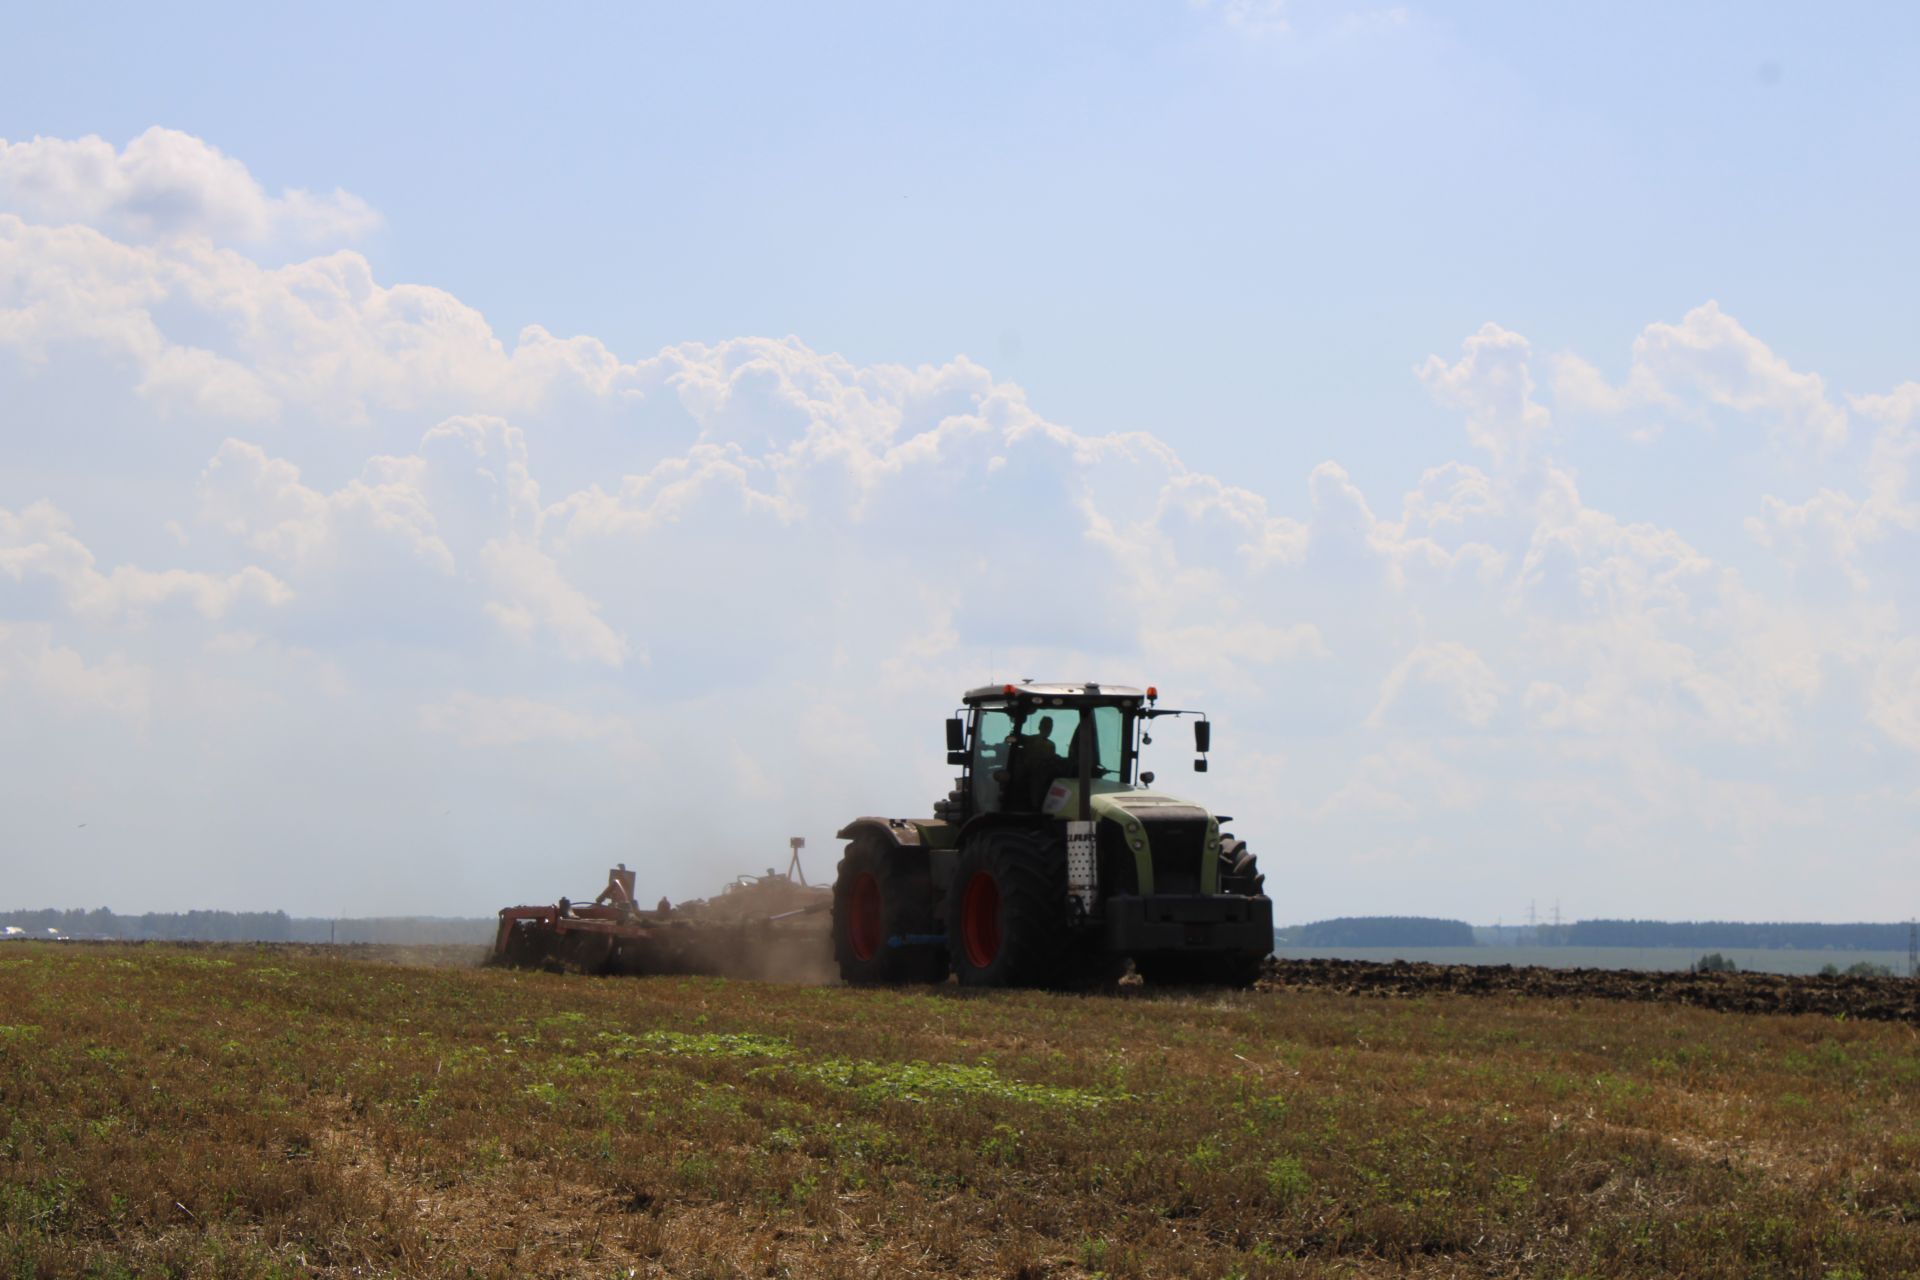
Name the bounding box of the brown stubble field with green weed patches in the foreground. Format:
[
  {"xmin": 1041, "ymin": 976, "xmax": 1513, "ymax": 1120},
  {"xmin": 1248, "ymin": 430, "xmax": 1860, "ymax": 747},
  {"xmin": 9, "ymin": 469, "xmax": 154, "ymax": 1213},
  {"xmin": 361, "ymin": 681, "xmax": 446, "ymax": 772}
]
[{"xmin": 0, "ymin": 944, "xmax": 1920, "ymax": 1278}]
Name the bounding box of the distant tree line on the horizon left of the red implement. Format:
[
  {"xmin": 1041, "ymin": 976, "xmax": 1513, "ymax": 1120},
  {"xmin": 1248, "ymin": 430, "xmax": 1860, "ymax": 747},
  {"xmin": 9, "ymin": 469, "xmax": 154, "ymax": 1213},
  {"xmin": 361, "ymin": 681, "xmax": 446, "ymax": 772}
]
[{"xmin": 0, "ymin": 906, "xmax": 495, "ymax": 944}]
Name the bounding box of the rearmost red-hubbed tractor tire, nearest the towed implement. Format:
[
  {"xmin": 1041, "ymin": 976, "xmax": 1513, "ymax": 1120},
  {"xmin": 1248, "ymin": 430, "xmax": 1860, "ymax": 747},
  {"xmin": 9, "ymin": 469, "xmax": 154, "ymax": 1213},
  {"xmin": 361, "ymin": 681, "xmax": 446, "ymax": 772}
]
[{"xmin": 833, "ymin": 837, "xmax": 947, "ymax": 986}]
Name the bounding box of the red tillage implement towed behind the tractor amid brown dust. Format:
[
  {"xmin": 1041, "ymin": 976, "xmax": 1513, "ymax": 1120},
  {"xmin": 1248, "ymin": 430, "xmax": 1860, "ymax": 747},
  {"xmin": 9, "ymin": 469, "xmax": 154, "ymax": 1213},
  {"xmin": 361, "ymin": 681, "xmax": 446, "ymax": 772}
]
[{"xmin": 492, "ymin": 846, "xmax": 833, "ymax": 979}]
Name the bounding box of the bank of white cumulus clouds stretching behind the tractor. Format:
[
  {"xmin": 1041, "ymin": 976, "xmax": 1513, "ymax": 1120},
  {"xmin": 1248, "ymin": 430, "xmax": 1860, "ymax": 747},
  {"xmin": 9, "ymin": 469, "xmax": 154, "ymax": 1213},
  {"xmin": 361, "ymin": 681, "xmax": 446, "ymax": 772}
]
[{"xmin": 0, "ymin": 124, "xmax": 1920, "ymax": 913}]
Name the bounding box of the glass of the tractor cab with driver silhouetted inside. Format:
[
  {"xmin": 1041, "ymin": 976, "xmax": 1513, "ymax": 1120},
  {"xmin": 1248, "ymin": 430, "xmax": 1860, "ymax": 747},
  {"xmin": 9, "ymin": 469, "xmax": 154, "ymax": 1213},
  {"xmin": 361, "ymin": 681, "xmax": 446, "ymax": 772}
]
[{"xmin": 973, "ymin": 706, "xmax": 1125, "ymax": 814}]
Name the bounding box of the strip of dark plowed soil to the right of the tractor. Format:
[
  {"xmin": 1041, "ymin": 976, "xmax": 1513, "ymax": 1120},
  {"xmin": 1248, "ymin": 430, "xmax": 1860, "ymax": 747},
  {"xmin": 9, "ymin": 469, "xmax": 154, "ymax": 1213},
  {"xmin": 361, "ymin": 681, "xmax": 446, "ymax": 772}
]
[{"xmin": 1260, "ymin": 960, "xmax": 1920, "ymax": 1023}]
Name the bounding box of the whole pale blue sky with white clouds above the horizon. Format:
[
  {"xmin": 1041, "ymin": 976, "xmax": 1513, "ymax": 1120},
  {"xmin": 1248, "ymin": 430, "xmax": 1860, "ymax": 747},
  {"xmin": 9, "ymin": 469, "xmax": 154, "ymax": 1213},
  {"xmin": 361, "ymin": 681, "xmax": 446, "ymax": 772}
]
[{"xmin": 0, "ymin": 0, "xmax": 1920, "ymax": 923}]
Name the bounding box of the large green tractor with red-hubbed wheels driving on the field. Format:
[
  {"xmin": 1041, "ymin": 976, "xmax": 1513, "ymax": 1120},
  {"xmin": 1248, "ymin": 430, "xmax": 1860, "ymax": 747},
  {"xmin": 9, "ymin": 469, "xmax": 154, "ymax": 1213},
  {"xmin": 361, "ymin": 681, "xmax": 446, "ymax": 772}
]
[{"xmin": 833, "ymin": 681, "xmax": 1273, "ymax": 986}]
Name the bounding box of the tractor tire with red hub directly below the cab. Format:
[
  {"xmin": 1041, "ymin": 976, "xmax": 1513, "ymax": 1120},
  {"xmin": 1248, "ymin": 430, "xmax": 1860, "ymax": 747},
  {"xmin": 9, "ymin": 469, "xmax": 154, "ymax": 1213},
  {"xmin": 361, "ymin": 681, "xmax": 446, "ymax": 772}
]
[{"xmin": 947, "ymin": 827, "xmax": 1071, "ymax": 986}]
